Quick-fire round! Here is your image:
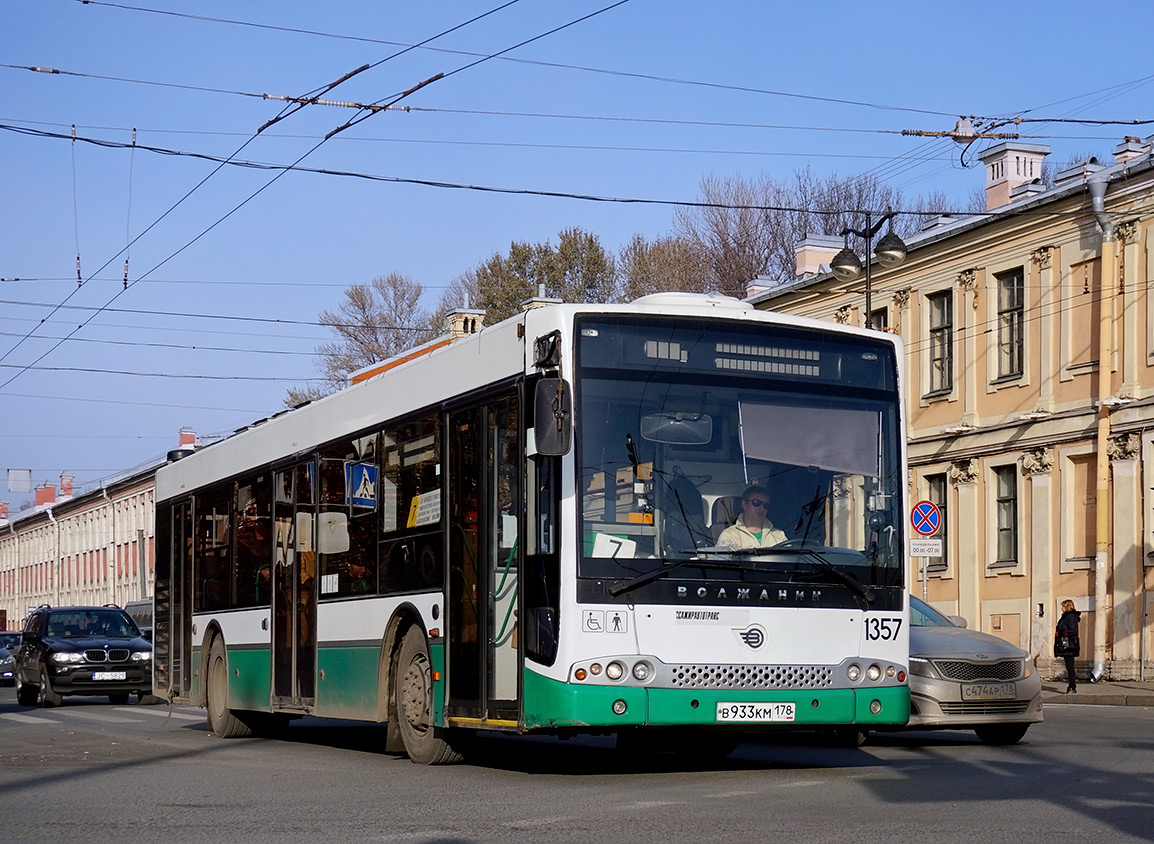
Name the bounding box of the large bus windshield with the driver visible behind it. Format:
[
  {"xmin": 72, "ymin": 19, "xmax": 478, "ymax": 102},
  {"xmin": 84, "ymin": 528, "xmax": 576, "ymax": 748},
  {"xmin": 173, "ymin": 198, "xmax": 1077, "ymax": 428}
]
[{"xmin": 577, "ymin": 316, "xmax": 905, "ymax": 600}]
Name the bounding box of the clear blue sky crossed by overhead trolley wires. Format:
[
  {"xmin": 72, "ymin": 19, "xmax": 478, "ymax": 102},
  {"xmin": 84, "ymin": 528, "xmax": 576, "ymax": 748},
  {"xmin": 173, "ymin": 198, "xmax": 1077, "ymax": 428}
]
[{"xmin": 0, "ymin": 0, "xmax": 1154, "ymax": 510}]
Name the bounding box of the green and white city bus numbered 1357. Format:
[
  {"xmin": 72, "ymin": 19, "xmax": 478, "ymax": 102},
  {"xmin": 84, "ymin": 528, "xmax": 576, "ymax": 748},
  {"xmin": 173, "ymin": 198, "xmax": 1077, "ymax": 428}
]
[{"xmin": 153, "ymin": 293, "xmax": 909, "ymax": 763}]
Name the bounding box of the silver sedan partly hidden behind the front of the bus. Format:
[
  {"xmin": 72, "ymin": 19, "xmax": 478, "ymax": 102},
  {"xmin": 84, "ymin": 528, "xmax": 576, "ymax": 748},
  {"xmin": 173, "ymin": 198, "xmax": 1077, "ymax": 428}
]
[{"xmin": 905, "ymin": 597, "xmax": 1042, "ymax": 745}]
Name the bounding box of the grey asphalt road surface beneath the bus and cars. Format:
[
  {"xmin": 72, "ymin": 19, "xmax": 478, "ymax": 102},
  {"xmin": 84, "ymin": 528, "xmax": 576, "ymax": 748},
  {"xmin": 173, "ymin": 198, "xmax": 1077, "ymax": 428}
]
[{"xmin": 0, "ymin": 688, "xmax": 1154, "ymax": 844}]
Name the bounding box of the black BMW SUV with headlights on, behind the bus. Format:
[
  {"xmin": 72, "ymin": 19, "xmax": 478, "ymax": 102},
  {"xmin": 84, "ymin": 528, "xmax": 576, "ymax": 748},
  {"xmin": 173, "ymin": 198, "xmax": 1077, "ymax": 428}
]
[{"xmin": 16, "ymin": 605, "xmax": 152, "ymax": 707}]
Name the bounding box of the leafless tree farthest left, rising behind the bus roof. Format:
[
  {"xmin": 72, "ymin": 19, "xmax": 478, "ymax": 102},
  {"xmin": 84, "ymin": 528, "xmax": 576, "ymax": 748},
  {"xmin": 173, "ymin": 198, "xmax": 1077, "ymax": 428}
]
[{"xmin": 285, "ymin": 272, "xmax": 440, "ymax": 406}]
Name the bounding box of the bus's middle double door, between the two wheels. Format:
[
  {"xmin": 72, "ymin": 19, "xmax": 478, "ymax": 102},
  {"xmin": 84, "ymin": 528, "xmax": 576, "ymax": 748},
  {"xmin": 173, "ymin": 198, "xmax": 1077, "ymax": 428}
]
[{"xmin": 272, "ymin": 461, "xmax": 316, "ymax": 709}]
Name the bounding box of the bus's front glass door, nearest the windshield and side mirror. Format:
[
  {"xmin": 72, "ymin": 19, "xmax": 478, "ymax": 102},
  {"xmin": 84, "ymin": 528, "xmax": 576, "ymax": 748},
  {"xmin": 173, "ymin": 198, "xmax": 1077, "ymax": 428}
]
[{"xmin": 447, "ymin": 394, "xmax": 524, "ymax": 722}]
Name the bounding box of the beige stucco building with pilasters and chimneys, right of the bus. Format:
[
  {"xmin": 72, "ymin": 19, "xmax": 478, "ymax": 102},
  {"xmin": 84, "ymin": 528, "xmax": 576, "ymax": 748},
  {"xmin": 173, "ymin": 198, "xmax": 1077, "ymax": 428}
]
[{"xmin": 751, "ymin": 137, "xmax": 1154, "ymax": 679}]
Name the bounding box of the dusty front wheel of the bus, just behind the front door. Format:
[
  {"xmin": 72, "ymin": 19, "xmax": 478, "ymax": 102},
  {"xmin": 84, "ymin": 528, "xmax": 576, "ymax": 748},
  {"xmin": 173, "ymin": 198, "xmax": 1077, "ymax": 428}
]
[{"xmin": 394, "ymin": 627, "xmax": 462, "ymax": 764}]
